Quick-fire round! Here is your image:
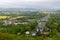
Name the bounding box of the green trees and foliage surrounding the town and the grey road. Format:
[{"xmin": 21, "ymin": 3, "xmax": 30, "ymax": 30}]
[{"xmin": 0, "ymin": 12, "xmax": 60, "ymax": 40}]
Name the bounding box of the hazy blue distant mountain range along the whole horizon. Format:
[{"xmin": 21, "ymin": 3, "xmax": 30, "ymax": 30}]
[{"xmin": 0, "ymin": 8, "xmax": 60, "ymax": 11}]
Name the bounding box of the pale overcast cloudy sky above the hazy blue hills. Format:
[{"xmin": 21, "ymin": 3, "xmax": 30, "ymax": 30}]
[{"xmin": 0, "ymin": 0, "xmax": 60, "ymax": 9}]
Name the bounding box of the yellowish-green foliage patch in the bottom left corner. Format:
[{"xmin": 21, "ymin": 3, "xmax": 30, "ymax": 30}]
[{"xmin": 0, "ymin": 33, "xmax": 17, "ymax": 40}]
